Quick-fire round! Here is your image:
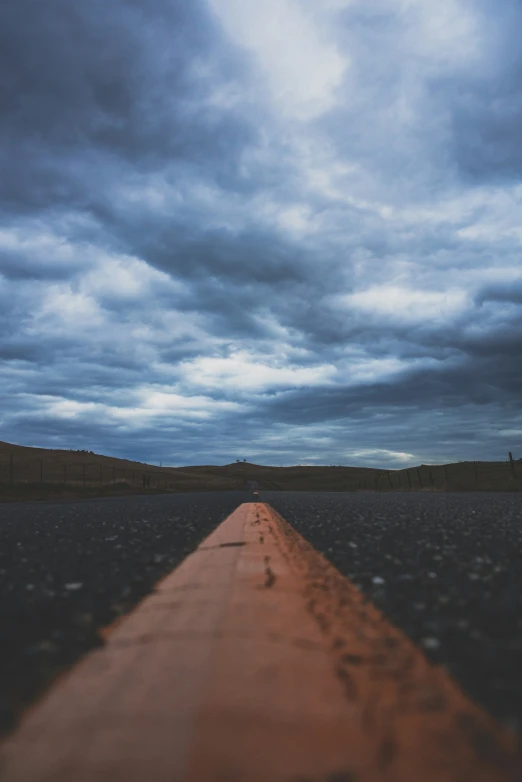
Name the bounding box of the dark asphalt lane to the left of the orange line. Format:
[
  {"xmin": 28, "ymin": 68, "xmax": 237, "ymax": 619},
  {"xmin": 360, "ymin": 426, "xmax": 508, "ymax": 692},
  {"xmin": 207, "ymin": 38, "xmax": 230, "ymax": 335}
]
[{"xmin": 0, "ymin": 492, "xmax": 250, "ymax": 732}]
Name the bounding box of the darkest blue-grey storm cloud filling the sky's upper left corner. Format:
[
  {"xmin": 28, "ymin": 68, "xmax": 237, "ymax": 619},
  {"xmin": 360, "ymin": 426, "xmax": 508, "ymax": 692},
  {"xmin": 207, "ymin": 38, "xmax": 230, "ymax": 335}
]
[{"xmin": 0, "ymin": 0, "xmax": 254, "ymax": 210}]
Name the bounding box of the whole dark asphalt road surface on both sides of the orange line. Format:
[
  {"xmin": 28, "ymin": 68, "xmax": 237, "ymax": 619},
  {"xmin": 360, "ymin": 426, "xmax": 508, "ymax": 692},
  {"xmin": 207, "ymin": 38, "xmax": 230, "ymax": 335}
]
[{"xmin": 0, "ymin": 491, "xmax": 522, "ymax": 730}]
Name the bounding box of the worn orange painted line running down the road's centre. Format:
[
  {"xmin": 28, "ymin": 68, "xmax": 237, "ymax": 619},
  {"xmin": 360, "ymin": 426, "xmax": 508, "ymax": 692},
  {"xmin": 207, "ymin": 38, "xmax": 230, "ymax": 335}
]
[{"xmin": 0, "ymin": 503, "xmax": 522, "ymax": 782}]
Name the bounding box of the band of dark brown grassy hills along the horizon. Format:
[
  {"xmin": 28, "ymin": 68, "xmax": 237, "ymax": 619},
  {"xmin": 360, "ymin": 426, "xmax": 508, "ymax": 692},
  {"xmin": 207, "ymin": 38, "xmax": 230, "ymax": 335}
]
[{"xmin": 0, "ymin": 442, "xmax": 522, "ymax": 502}]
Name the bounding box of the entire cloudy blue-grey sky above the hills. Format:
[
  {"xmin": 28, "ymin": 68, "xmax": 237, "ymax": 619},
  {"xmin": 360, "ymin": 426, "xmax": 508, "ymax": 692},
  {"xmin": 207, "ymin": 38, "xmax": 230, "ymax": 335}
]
[{"xmin": 0, "ymin": 0, "xmax": 522, "ymax": 469}]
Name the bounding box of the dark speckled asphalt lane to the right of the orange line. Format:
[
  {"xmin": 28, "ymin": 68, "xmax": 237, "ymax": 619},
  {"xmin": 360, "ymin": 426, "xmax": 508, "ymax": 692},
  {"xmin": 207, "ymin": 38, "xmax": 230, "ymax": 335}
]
[{"xmin": 261, "ymin": 491, "xmax": 522, "ymax": 731}]
